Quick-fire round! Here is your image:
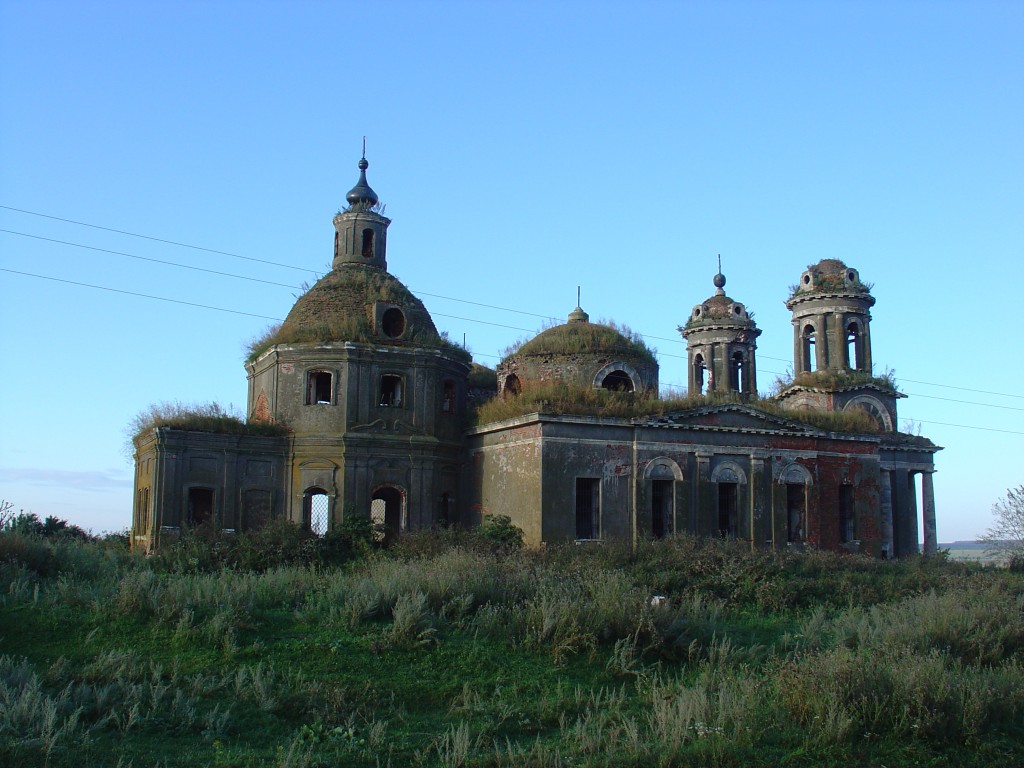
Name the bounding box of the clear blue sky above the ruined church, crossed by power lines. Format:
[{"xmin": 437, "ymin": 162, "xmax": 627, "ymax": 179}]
[{"xmin": 0, "ymin": 0, "xmax": 1024, "ymax": 541}]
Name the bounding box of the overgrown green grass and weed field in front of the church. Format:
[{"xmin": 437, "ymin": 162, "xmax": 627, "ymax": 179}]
[{"xmin": 0, "ymin": 526, "xmax": 1024, "ymax": 768}]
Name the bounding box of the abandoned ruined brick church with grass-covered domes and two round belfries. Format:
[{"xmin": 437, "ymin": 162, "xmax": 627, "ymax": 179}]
[{"xmin": 132, "ymin": 158, "xmax": 940, "ymax": 557}]
